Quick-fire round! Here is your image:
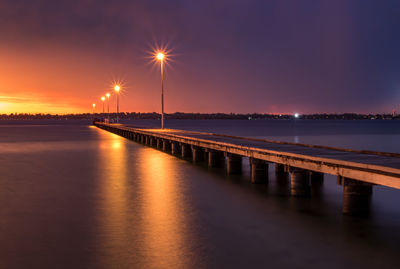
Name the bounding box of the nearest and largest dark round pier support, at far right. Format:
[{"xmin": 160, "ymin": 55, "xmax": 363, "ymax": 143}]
[{"xmin": 342, "ymin": 178, "xmax": 372, "ymax": 216}]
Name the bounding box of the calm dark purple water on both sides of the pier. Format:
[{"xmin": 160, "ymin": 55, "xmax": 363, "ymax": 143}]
[{"xmin": 0, "ymin": 121, "xmax": 400, "ymax": 268}]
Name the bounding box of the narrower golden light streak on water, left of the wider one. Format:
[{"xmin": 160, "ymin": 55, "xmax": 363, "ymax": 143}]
[{"xmin": 98, "ymin": 130, "xmax": 130, "ymax": 260}]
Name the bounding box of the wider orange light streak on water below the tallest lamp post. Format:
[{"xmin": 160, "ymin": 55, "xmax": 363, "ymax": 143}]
[{"xmin": 138, "ymin": 148, "xmax": 190, "ymax": 268}]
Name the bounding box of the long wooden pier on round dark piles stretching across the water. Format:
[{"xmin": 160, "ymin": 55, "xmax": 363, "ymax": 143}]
[{"xmin": 94, "ymin": 122, "xmax": 400, "ymax": 215}]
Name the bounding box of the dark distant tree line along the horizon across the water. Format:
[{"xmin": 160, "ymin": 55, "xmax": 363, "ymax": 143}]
[{"xmin": 0, "ymin": 112, "xmax": 400, "ymax": 120}]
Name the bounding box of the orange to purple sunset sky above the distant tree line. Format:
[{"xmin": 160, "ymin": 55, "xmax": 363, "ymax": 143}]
[{"xmin": 0, "ymin": 0, "xmax": 400, "ymax": 114}]
